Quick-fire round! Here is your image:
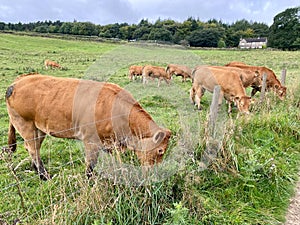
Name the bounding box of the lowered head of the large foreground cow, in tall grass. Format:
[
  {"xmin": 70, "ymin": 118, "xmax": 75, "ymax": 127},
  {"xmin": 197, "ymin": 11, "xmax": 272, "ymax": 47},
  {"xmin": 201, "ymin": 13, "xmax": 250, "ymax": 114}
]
[{"xmin": 135, "ymin": 130, "xmax": 171, "ymax": 167}]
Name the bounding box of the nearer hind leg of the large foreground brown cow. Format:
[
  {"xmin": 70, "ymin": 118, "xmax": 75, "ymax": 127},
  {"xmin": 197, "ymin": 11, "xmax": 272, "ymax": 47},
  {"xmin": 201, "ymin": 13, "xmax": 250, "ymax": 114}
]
[{"xmin": 12, "ymin": 120, "xmax": 51, "ymax": 180}]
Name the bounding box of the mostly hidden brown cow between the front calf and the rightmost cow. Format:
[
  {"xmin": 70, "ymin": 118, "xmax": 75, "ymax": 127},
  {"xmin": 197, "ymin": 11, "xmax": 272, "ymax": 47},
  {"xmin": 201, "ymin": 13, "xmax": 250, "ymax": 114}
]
[{"xmin": 212, "ymin": 66, "xmax": 262, "ymax": 88}]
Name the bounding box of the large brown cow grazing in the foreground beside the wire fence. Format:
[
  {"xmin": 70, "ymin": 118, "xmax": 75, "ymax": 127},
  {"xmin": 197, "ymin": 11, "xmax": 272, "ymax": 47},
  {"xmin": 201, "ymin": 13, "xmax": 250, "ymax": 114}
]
[{"xmin": 6, "ymin": 75, "xmax": 171, "ymax": 179}]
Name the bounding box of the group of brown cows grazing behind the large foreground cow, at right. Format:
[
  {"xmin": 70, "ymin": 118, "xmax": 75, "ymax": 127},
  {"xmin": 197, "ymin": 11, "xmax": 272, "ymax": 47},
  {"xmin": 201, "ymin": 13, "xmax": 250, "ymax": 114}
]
[{"xmin": 128, "ymin": 61, "xmax": 286, "ymax": 114}]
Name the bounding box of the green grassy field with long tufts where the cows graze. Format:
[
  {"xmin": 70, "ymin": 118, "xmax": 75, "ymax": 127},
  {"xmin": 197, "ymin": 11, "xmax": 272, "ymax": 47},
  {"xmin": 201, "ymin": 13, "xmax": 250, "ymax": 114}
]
[{"xmin": 0, "ymin": 34, "xmax": 300, "ymax": 224}]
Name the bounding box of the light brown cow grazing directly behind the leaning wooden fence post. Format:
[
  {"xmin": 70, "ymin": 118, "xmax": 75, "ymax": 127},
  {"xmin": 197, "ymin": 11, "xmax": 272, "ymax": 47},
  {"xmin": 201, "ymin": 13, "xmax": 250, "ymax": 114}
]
[{"xmin": 190, "ymin": 66, "xmax": 251, "ymax": 114}]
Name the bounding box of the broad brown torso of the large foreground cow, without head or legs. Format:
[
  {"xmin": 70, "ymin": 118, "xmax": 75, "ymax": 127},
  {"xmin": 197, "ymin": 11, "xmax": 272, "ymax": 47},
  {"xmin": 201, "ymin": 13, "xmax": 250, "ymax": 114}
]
[{"xmin": 7, "ymin": 75, "xmax": 159, "ymax": 142}]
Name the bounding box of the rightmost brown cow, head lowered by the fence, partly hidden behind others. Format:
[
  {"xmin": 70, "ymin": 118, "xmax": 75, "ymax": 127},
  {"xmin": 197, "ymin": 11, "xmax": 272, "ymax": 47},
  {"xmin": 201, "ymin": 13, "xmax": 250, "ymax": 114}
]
[{"xmin": 226, "ymin": 62, "xmax": 286, "ymax": 100}]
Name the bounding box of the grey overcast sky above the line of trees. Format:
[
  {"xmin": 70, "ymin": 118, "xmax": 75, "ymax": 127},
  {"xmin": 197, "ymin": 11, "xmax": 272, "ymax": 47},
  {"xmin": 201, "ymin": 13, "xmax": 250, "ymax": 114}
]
[{"xmin": 0, "ymin": 0, "xmax": 300, "ymax": 25}]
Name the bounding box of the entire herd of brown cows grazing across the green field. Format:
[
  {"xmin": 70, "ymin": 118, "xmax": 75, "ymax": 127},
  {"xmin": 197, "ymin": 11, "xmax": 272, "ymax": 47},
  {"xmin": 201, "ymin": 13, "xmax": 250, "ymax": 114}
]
[{"xmin": 5, "ymin": 61, "xmax": 286, "ymax": 179}]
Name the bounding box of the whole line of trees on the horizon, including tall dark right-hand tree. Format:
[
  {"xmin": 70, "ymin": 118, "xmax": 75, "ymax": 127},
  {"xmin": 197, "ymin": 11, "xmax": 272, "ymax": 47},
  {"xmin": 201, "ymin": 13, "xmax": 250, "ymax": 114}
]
[{"xmin": 0, "ymin": 7, "xmax": 300, "ymax": 50}]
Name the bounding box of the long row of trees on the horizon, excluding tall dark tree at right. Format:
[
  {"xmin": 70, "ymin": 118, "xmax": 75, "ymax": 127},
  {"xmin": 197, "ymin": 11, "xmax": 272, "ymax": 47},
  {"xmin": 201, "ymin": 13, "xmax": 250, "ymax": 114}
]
[{"xmin": 0, "ymin": 17, "xmax": 269, "ymax": 47}]
